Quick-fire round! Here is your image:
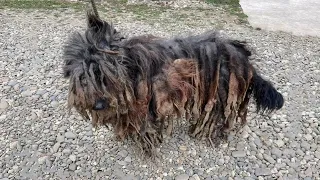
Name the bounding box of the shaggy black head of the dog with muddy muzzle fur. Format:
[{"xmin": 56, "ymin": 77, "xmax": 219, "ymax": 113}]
[{"xmin": 63, "ymin": 13, "xmax": 130, "ymax": 126}]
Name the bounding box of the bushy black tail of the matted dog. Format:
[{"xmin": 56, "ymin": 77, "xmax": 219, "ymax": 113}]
[{"xmin": 252, "ymin": 71, "xmax": 284, "ymax": 112}]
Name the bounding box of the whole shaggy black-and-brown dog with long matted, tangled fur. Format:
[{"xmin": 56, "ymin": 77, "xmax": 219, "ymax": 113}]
[{"xmin": 63, "ymin": 13, "xmax": 284, "ymax": 154}]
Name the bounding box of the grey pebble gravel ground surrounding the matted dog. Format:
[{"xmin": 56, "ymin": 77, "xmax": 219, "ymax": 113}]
[{"xmin": 0, "ymin": 2, "xmax": 320, "ymax": 180}]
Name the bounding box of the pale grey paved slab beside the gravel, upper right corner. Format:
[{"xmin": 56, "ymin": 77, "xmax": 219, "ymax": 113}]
[{"xmin": 240, "ymin": 0, "xmax": 320, "ymax": 37}]
